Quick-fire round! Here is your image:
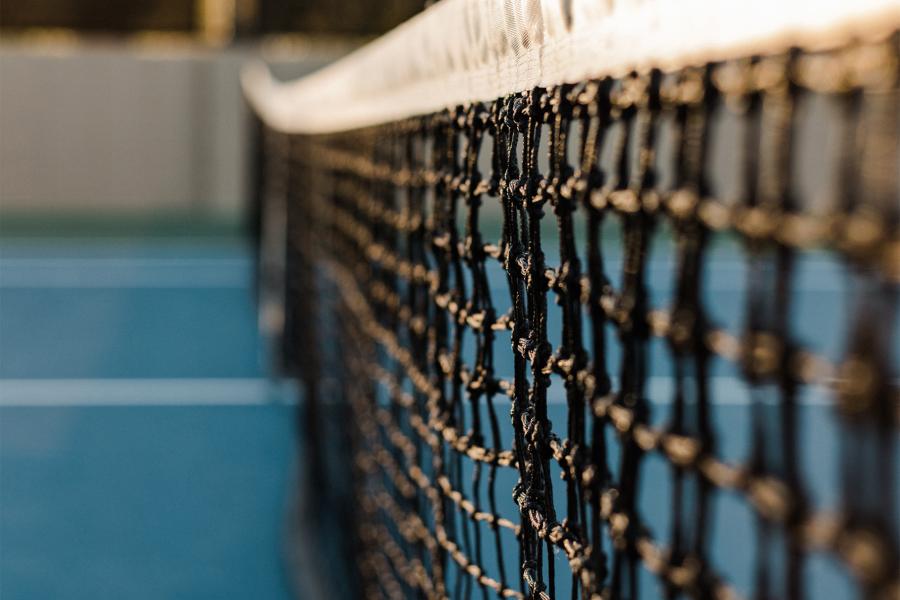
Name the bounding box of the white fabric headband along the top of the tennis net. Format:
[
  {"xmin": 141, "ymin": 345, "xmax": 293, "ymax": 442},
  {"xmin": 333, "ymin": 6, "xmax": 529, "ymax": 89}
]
[{"xmin": 242, "ymin": 0, "xmax": 900, "ymax": 134}]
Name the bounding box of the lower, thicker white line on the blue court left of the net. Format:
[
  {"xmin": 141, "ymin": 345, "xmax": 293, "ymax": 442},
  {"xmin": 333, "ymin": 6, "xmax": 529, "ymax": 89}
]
[{"xmin": 0, "ymin": 378, "xmax": 297, "ymax": 408}]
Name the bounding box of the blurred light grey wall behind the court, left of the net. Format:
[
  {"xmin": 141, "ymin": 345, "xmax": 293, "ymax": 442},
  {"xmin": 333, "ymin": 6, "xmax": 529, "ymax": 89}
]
[{"xmin": 0, "ymin": 43, "xmax": 331, "ymax": 218}]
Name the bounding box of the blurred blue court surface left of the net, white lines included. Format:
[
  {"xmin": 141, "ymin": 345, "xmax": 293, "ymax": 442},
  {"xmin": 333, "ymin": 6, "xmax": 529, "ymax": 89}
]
[{"xmin": 0, "ymin": 238, "xmax": 295, "ymax": 600}]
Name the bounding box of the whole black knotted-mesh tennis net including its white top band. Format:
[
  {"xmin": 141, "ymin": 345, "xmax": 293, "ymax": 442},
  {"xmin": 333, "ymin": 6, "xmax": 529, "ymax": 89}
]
[{"xmin": 245, "ymin": 0, "xmax": 900, "ymax": 599}]
